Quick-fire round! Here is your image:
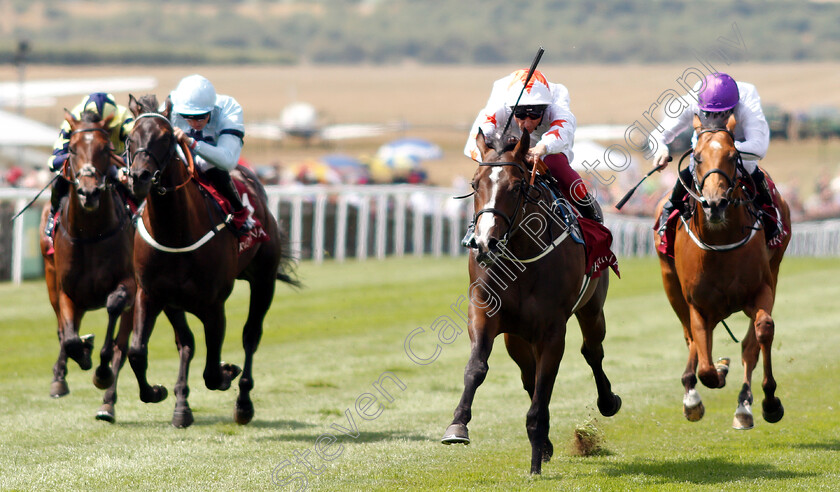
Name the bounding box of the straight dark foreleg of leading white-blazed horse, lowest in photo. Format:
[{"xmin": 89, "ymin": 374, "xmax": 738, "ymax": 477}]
[{"xmin": 525, "ymin": 332, "xmax": 566, "ymax": 474}]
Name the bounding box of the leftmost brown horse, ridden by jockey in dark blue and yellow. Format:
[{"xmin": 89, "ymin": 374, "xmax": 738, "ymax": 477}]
[{"xmin": 40, "ymin": 112, "xmax": 136, "ymax": 422}]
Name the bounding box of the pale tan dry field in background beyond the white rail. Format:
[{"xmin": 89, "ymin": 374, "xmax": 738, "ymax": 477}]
[{"xmin": 6, "ymin": 62, "xmax": 840, "ymax": 208}]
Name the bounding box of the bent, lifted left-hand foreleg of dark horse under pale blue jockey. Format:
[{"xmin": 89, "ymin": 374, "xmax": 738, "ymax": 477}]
[{"xmin": 128, "ymin": 288, "xmax": 167, "ymax": 403}]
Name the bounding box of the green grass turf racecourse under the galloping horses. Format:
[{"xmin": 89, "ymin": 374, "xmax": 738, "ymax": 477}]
[{"xmin": 0, "ymin": 258, "xmax": 840, "ymax": 491}]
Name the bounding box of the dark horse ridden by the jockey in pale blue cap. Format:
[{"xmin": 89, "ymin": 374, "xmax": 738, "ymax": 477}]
[{"xmin": 127, "ymin": 96, "xmax": 297, "ymax": 427}]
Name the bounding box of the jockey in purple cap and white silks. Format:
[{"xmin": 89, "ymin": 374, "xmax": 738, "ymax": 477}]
[{"xmin": 651, "ymin": 72, "xmax": 779, "ymax": 240}]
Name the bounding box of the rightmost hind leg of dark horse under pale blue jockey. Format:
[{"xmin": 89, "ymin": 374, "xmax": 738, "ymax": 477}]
[{"xmin": 233, "ymin": 274, "xmax": 277, "ymax": 425}]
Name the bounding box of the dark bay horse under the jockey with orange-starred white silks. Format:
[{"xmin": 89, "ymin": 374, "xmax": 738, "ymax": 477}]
[{"xmin": 442, "ymin": 132, "xmax": 621, "ymax": 474}]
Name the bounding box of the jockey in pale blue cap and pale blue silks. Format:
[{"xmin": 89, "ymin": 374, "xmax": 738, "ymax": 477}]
[{"xmin": 170, "ymin": 74, "xmax": 254, "ymax": 234}]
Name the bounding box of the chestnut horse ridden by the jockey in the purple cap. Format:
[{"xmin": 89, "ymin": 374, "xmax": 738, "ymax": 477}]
[{"xmin": 654, "ymin": 116, "xmax": 790, "ymax": 429}]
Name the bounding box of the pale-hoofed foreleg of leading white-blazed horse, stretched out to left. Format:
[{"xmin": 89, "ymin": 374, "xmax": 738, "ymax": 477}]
[{"xmin": 441, "ymin": 312, "xmax": 499, "ymax": 444}]
